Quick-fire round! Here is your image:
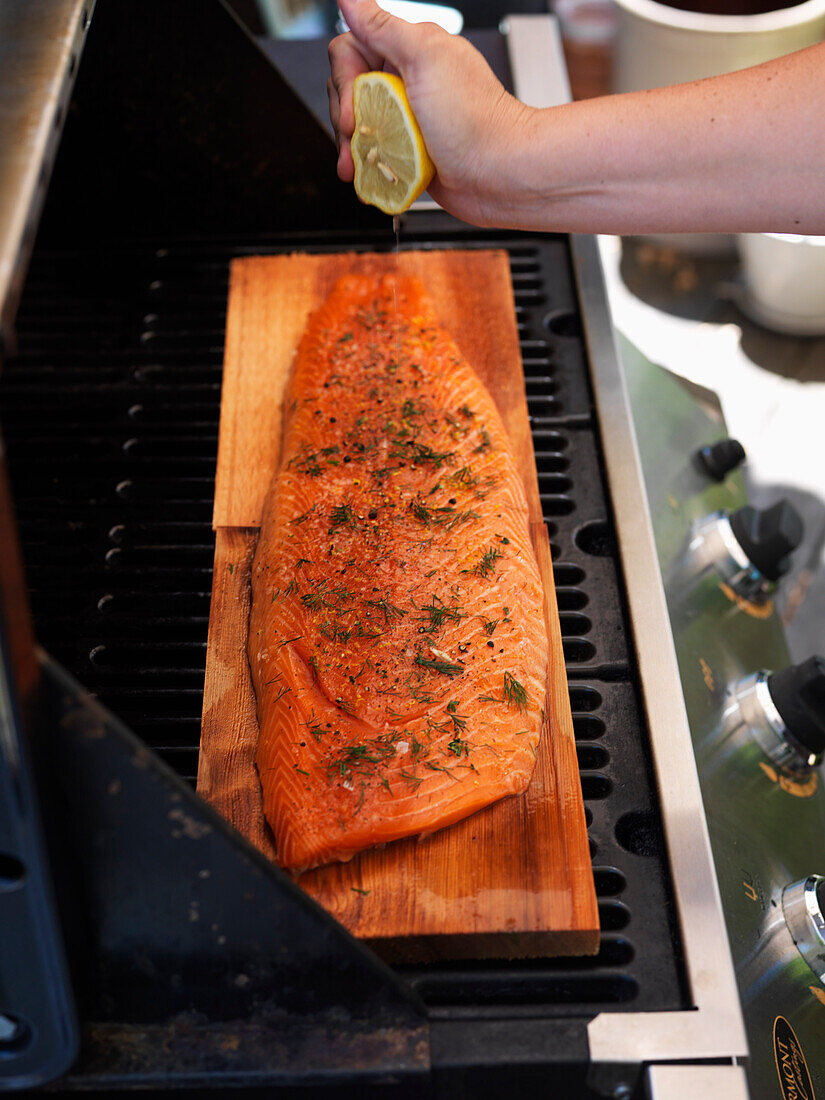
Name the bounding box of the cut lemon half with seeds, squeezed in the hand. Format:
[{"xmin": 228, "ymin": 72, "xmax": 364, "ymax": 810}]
[{"xmin": 351, "ymin": 73, "xmax": 436, "ymax": 213}]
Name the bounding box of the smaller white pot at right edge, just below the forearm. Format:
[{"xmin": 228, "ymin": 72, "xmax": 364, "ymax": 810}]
[{"xmin": 739, "ymin": 233, "xmax": 825, "ymax": 336}]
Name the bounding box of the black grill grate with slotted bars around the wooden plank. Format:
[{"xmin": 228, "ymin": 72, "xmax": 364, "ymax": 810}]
[{"xmin": 0, "ymin": 219, "xmax": 684, "ymax": 1016}]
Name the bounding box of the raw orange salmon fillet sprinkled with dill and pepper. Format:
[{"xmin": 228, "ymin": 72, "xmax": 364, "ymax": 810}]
[{"xmin": 249, "ymin": 275, "xmax": 548, "ymax": 872}]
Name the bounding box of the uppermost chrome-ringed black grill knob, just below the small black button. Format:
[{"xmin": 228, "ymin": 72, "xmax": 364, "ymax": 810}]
[{"xmin": 675, "ymin": 501, "xmax": 803, "ymax": 604}]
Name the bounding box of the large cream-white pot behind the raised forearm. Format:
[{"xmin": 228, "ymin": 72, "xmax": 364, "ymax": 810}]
[{"xmin": 613, "ymin": 0, "xmax": 825, "ymax": 255}]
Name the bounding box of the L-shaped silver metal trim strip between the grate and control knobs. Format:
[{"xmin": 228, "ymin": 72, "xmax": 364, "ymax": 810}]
[{"xmin": 571, "ymin": 235, "xmax": 748, "ymax": 1063}]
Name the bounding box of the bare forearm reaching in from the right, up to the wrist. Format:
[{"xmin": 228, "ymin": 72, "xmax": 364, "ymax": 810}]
[{"xmin": 479, "ymin": 44, "xmax": 825, "ymax": 233}]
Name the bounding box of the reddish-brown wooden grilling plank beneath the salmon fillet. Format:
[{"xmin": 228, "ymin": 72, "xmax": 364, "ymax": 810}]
[{"xmin": 198, "ymin": 251, "xmax": 598, "ymax": 959}]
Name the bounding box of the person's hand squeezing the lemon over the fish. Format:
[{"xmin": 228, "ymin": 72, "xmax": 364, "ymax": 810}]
[{"xmin": 327, "ymin": 0, "xmax": 534, "ymax": 226}]
